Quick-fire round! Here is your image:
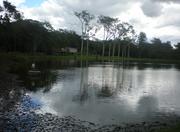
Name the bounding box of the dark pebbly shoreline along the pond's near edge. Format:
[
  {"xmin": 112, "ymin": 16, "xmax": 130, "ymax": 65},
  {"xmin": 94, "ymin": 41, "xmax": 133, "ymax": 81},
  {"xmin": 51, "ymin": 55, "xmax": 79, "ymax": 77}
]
[{"xmin": 0, "ymin": 101, "xmax": 180, "ymax": 132}]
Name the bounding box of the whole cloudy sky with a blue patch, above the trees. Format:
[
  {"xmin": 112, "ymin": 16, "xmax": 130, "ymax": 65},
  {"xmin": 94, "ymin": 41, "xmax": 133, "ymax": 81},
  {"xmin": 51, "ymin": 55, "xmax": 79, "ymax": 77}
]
[{"xmin": 0, "ymin": 0, "xmax": 180, "ymax": 43}]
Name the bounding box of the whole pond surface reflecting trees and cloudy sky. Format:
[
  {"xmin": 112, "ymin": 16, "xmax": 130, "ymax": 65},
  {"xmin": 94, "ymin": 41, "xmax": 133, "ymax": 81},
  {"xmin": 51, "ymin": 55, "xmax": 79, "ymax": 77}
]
[{"xmin": 5, "ymin": 61, "xmax": 180, "ymax": 124}]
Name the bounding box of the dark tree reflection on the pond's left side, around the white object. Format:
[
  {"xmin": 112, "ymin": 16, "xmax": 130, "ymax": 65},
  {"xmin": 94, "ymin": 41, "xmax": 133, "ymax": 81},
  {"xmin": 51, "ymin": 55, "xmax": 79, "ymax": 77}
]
[{"xmin": 11, "ymin": 62, "xmax": 57, "ymax": 92}]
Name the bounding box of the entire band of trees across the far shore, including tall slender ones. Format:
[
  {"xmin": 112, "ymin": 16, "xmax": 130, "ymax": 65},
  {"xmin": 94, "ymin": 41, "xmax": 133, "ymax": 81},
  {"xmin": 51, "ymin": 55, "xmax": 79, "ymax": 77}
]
[{"xmin": 0, "ymin": 1, "xmax": 180, "ymax": 59}]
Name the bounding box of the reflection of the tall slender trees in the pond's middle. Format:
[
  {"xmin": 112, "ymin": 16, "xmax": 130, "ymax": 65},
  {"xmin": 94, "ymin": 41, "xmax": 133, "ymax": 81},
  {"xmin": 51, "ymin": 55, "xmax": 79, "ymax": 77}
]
[{"xmin": 73, "ymin": 61, "xmax": 136, "ymax": 104}]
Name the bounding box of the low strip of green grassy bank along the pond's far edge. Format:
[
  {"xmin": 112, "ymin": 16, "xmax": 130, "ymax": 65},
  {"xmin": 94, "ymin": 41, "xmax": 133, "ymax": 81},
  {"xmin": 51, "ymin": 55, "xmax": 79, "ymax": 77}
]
[{"xmin": 0, "ymin": 53, "xmax": 180, "ymax": 63}]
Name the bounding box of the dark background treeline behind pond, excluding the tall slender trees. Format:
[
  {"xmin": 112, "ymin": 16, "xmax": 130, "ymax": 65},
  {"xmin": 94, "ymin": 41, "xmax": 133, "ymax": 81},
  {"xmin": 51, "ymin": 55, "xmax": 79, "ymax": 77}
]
[{"xmin": 0, "ymin": 1, "xmax": 180, "ymax": 59}]
